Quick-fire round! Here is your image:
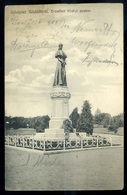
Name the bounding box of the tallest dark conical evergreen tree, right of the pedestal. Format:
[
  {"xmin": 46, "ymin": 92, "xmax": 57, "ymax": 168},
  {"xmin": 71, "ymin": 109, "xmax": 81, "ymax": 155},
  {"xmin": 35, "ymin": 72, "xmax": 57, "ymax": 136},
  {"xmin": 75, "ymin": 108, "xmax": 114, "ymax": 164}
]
[{"xmin": 77, "ymin": 100, "xmax": 93, "ymax": 135}]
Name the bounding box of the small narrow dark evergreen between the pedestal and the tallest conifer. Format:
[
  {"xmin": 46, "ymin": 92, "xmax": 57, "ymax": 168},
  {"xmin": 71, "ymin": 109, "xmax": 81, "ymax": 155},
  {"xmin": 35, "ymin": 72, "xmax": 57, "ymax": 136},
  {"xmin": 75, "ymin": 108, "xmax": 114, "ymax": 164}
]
[{"xmin": 70, "ymin": 107, "xmax": 79, "ymax": 129}]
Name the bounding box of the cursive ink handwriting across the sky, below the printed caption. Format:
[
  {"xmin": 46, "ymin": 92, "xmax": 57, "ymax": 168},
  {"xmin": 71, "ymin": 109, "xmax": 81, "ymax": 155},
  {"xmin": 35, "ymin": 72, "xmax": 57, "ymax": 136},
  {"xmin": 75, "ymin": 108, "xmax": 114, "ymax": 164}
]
[{"xmin": 9, "ymin": 10, "xmax": 120, "ymax": 67}]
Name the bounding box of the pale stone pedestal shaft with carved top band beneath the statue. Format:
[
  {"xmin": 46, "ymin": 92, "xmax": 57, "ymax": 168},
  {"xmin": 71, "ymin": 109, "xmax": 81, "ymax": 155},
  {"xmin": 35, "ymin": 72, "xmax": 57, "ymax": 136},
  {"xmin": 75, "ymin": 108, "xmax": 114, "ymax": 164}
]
[{"xmin": 49, "ymin": 86, "xmax": 71, "ymax": 129}]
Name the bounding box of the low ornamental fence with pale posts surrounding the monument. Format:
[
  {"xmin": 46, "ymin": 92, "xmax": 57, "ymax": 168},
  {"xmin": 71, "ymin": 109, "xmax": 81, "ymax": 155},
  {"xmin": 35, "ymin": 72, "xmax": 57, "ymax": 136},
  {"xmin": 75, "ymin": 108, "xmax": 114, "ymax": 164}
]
[{"xmin": 5, "ymin": 135, "xmax": 123, "ymax": 151}]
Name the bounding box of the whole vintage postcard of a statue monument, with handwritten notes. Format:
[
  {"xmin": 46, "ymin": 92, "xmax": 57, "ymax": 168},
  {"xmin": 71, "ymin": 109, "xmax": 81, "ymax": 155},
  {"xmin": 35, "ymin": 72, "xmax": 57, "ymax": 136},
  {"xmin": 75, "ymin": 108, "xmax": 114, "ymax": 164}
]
[{"xmin": 5, "ymin": 3, "xmax": 124, "ymax": 191}]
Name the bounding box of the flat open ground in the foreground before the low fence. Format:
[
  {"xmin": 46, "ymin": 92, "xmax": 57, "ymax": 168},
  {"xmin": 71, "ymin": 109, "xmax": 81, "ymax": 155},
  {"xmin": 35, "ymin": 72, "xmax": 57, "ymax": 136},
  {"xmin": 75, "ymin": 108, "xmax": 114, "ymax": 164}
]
[{"xmin": 5, "ymin": 147, "xmax": 123, "ymax": 191}]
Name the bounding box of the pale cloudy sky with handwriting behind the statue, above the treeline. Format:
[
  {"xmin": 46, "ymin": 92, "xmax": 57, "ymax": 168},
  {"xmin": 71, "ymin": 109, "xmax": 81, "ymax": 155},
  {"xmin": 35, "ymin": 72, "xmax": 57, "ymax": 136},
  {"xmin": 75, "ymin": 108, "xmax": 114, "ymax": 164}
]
[{"xmin": 5, "ymin": 4, "xmax": 123, "ymax": 117}]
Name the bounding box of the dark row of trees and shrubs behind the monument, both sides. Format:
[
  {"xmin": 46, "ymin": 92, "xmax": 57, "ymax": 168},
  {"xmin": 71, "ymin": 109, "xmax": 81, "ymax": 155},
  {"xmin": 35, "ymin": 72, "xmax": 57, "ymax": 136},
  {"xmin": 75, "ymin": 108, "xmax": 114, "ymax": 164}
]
[{"xmin": 5, "ymin": 108, "xmax": 124, "ymax": 134}]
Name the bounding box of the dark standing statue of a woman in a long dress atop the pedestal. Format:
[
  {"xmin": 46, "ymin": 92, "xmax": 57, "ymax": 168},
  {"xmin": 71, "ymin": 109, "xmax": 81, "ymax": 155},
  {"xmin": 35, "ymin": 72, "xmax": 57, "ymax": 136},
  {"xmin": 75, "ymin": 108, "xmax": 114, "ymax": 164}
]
[{"xmin": 53, "ymin": 43, "xmax": 67, "ymax": 86}]
